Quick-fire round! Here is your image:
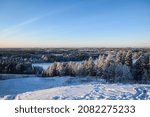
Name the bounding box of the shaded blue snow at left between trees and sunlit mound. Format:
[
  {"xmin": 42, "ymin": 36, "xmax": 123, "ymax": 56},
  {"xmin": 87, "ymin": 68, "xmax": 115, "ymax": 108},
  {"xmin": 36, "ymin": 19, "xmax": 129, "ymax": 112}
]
[{"xmin": 0, "ymin": 75, "xmax": 70, "ymax": 99}]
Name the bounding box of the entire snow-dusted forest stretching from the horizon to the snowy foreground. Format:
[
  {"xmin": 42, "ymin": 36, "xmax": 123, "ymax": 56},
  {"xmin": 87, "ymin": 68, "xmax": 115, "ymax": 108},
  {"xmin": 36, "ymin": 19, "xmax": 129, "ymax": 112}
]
[{"xmin": 0, "ymin": 48, "xmax": 150, "ymax": 83}]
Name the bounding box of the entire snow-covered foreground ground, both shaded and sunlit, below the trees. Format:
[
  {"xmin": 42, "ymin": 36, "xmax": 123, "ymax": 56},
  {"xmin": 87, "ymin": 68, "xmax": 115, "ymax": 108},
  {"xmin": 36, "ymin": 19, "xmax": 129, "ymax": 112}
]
[{"xmin": 0, "ymin": 76, "xmax": 150, "ymax": 100}]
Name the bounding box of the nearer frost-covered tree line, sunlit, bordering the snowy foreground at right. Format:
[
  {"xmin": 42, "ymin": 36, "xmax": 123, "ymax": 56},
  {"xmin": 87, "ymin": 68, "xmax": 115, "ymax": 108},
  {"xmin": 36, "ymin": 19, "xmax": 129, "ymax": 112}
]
[{"xmin": 42, "ymin": 50, "xmax": 150, "ymax": 83}]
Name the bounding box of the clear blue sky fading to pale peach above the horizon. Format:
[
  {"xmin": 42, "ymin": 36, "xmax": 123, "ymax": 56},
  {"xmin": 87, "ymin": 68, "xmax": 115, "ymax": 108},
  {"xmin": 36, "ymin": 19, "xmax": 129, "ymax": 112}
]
[{"xmin": 0, "ymin": 0, "xmax": 150, "ymax": 47}]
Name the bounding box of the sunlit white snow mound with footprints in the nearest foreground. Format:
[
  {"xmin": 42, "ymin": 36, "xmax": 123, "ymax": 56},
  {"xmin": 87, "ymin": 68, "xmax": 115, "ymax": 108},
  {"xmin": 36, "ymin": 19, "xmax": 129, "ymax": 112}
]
[{"xmin": 15, "ymin": 82, "xmax": 150, "ymax": 100}]
